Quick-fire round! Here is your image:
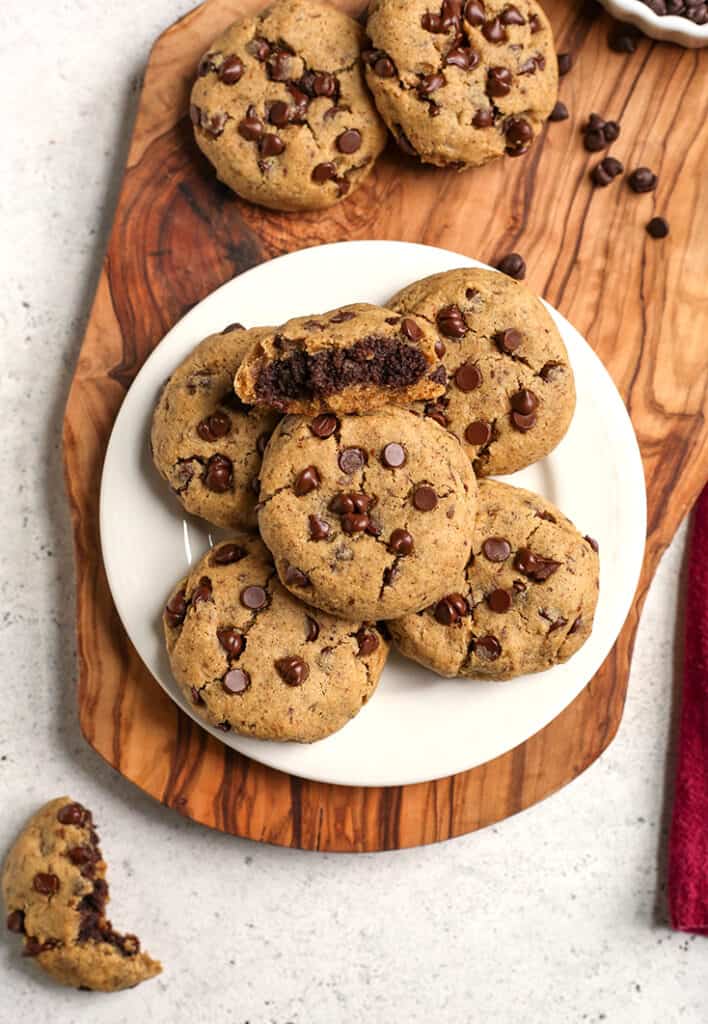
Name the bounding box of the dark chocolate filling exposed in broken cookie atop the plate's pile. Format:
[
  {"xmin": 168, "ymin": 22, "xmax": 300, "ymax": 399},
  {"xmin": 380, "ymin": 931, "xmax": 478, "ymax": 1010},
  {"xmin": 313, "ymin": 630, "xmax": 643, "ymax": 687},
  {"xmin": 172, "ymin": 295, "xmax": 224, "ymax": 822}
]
[{"xmin": 256, "ymin": 336, "xmax": 427, "ymax": 408}]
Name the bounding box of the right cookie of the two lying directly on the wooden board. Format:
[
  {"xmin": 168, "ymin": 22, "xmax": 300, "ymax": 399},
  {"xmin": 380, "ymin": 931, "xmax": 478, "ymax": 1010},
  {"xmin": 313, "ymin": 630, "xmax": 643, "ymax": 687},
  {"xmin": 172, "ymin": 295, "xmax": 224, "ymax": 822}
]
[{"xmin": 363, "ymin": 0, "xmax": 558, "ymax": 169}]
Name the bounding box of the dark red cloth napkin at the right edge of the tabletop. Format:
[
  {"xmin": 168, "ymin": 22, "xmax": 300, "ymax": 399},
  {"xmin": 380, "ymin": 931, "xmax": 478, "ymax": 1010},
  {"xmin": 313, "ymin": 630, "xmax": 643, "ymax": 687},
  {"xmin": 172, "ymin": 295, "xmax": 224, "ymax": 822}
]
[{"xmin": 669, "ymin": 486, "xmax": 708, "ymax": 935}]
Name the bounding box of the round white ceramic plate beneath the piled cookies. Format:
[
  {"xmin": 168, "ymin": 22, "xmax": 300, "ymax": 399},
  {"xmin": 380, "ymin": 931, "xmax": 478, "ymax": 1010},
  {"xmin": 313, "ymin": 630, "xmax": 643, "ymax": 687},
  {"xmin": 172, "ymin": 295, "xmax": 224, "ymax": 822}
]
[{"xmin": 100, "ymin": 242, "xmax": 647, "ymax": 785}]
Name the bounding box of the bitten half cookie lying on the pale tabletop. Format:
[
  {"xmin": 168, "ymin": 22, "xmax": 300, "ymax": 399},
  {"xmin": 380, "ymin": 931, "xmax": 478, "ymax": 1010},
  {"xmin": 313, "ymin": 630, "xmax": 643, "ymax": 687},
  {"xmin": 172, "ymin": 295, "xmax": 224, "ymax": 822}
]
[{"xmin": 2, "ymin": 797, "xmax": 162, "ymax": 992}]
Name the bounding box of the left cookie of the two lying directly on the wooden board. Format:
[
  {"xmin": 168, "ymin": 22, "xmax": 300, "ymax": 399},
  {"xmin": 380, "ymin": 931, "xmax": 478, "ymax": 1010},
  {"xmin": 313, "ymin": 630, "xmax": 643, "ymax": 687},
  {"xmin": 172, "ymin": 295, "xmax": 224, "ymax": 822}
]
[{"xmin": 190, "ymin": 0, "xmax": 386, "ymax": 210}]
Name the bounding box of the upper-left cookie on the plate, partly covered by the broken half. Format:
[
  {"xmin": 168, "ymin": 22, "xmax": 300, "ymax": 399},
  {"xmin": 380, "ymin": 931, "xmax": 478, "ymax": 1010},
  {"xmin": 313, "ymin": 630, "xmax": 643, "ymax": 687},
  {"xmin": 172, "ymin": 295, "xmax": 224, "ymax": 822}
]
[{"xmin": 151, "ymin": 325, "xmax": 279, "ymax": 529}]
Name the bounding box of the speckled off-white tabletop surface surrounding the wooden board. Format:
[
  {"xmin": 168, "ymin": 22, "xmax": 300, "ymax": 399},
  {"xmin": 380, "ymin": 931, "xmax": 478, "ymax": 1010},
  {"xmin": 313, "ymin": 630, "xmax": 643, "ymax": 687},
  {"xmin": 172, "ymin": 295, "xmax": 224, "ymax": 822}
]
[{"xmin": 0, "ymin": 0, "xmax": 708, "ymax": 1024}]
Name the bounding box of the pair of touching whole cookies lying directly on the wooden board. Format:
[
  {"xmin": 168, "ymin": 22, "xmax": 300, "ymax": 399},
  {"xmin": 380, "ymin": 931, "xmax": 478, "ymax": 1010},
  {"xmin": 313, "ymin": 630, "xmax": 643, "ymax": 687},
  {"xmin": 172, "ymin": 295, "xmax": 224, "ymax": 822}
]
[{"xmin": 190, "ymin": 0, "xmax": 558, "ymax": 211}]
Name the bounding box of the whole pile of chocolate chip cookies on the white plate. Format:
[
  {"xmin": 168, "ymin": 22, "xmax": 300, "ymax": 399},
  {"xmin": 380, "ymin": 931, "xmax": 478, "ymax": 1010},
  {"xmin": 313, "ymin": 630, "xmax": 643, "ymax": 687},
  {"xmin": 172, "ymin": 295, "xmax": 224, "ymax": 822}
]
[{"xmin": 152, "ymin": 268, "xmax": 598, "ymax": 741}]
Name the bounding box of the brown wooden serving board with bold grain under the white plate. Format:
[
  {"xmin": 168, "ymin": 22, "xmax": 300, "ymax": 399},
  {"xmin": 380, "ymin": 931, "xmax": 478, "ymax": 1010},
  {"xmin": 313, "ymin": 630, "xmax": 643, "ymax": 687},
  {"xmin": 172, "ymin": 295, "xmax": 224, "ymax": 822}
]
[{"xmin": 65, "ymin": 0, "xmax": 708, "ymax": 851}]
